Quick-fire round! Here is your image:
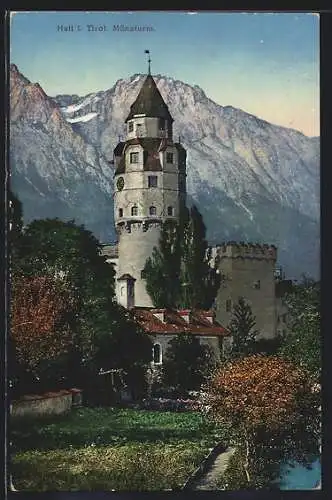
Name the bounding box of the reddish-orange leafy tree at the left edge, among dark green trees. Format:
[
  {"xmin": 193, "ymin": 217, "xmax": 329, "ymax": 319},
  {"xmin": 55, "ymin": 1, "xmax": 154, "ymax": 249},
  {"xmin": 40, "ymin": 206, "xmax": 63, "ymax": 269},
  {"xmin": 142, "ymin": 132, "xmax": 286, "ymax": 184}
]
[{"xmin": 11, "ymin": 276, "xmax": 72, "ymax": 372}]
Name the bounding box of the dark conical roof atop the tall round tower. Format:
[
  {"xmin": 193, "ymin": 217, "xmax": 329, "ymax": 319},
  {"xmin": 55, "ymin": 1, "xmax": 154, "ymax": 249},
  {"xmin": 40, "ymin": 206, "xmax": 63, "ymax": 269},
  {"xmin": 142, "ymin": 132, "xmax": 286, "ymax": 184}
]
[{"xmin": 126, "ymin": 75, "xmax": 174, "ymax": 122}]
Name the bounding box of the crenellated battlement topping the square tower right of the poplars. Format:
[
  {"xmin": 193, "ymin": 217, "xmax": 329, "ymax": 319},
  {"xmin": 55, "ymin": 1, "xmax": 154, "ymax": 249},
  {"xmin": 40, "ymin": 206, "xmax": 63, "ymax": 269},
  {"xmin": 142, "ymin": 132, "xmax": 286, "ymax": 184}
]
[{"xmin": 209, "ymin": 241, "xmax": 277, "ymax": 262}]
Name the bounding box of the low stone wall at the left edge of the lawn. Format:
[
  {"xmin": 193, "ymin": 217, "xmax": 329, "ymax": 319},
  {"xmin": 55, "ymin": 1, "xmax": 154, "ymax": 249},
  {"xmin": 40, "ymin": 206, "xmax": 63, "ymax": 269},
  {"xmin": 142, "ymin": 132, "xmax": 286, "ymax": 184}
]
[{"xmin": 10, "ymin": 389, "xmax": 82, "ymax": 417}]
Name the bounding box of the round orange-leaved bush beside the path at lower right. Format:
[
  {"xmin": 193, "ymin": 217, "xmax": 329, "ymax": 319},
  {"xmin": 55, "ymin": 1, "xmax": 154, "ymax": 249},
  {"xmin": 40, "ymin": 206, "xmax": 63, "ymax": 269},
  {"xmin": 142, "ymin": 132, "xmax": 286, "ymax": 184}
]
[{"xmin": 206, "ymin": 355, "xmax": 319, "ymax": 487}]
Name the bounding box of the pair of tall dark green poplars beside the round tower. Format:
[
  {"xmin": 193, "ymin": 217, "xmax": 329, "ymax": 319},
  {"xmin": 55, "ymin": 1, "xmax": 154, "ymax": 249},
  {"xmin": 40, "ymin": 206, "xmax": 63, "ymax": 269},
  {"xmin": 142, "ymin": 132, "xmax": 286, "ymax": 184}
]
[{"xmin": 144, "ymin": 206, "xmax": 220, "ymax": 309}]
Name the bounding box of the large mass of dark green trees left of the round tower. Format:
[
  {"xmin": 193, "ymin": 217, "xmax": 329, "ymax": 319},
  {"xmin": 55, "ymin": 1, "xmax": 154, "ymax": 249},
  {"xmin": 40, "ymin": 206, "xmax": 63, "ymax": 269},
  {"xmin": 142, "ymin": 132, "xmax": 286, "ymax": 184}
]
[{"xmin": 9, "ymin": 219, "xmax": 151, "ymax": 394}]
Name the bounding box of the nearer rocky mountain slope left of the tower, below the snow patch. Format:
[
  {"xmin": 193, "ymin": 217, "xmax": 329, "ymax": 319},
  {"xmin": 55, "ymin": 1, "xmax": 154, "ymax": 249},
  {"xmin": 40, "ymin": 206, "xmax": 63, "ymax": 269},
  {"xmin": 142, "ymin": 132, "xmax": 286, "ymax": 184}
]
[{"xmin": 10, "ymin": 65, "xmax": 114, "ymax": 241}]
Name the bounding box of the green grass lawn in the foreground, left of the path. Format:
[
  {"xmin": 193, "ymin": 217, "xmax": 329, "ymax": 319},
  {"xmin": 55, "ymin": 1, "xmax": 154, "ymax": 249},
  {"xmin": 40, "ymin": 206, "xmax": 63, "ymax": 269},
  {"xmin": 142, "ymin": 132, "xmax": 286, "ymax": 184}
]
[{"xmin": 11, "ymin": 408, "xmax": 226, "ymax": 491}]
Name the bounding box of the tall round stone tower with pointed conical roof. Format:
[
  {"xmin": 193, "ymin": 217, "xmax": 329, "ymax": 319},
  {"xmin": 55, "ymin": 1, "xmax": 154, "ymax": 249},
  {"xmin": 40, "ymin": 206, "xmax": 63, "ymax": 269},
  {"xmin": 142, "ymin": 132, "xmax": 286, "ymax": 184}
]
[{"xmin": 114, "ymin": 72, "xmax": 186, "ymax": 308}]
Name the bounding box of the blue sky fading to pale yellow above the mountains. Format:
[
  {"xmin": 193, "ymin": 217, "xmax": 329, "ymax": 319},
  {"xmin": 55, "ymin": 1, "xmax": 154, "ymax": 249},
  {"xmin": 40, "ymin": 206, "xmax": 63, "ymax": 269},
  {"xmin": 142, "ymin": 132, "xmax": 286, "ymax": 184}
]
[{"xmin": 10, "ymin": 11, "xmax": 320, "ymax": 136}]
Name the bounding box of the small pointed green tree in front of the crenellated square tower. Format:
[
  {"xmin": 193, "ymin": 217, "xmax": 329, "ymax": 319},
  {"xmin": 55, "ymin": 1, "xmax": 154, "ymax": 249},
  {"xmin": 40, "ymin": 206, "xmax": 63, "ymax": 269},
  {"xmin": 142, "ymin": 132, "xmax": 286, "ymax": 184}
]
[{"xmin": 227, "ymin": 297, "xmax": 257, "ymax": 358}]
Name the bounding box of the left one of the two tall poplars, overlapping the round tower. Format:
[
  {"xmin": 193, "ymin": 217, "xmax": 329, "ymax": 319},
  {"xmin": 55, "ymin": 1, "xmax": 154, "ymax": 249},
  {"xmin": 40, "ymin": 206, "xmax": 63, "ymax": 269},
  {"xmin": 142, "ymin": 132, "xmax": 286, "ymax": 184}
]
[{"xmin": 144, "ymin": 220, "xmax": 181, "ymax": 308}]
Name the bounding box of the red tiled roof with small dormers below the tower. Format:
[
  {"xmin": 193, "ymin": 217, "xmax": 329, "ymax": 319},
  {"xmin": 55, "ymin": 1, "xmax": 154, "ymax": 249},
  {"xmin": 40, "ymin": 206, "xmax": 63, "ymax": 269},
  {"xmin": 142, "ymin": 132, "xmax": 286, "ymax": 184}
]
[{"xmin": 132, "ymin": 308, "xmax": 229, "ymax": 336}]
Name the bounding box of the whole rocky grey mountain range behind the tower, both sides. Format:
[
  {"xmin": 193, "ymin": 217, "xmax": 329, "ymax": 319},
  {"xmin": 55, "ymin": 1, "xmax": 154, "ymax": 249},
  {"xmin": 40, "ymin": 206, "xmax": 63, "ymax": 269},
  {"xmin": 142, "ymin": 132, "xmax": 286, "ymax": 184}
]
[{"xmin": 10, "ymin": 65, "xmax": 320, "ymax": 277}]
